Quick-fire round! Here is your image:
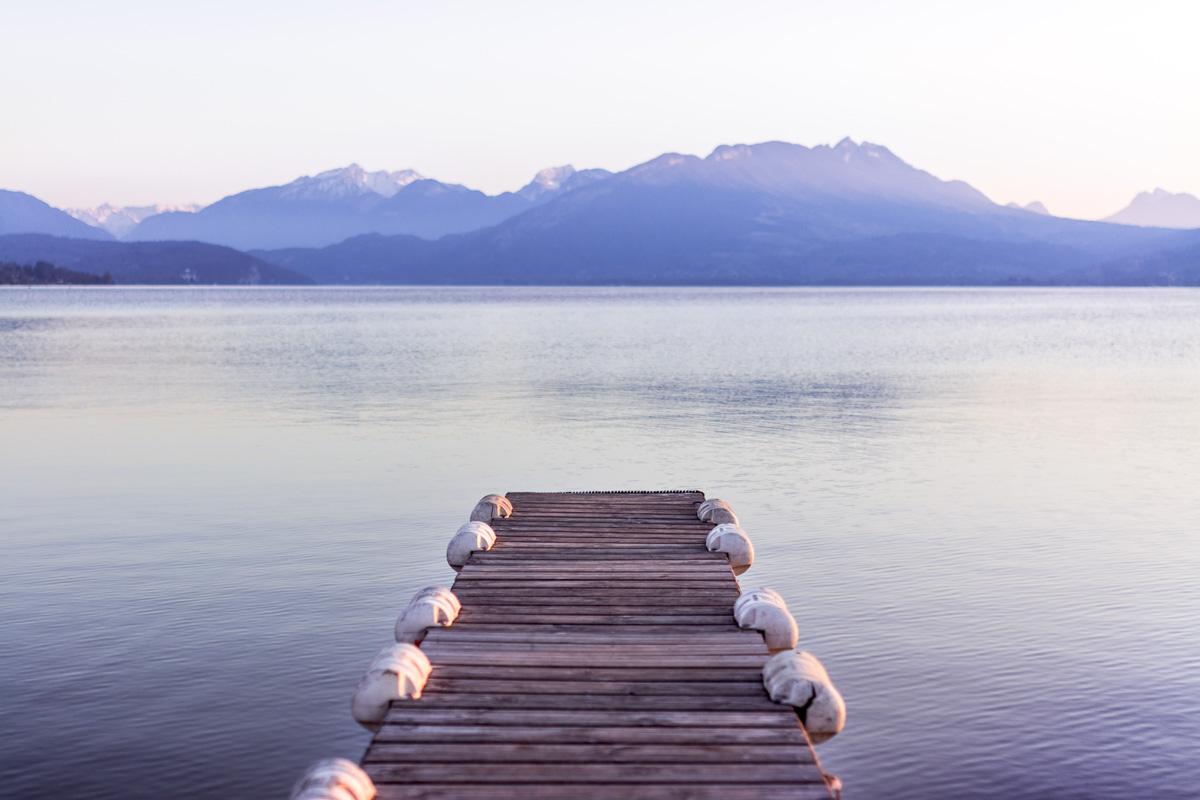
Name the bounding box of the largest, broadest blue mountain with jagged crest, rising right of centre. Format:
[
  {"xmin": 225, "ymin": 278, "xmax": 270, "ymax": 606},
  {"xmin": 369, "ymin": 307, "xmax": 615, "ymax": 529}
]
[{"xmin": 257, "ymin": 139, "xmax": 1193, "ymax": 284}]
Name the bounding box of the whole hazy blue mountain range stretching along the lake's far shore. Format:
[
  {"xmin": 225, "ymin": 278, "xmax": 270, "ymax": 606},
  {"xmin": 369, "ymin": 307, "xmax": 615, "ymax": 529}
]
[{"xmin": 0, "ymin": 139, "xmax": 1200, "ymax": 284}]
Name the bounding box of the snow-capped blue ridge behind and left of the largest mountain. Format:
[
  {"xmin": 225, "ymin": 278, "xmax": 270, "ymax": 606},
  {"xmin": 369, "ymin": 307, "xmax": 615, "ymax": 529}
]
[{"xmin": 126, "ymin": 164, "xmax": 608, "ymax": 249}]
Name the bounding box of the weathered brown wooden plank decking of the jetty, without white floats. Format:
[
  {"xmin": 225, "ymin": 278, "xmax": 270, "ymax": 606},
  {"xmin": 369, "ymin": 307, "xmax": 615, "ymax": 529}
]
[{"xmin": 362, "ymin": 492, "xmax": 830, "ymax": 800}]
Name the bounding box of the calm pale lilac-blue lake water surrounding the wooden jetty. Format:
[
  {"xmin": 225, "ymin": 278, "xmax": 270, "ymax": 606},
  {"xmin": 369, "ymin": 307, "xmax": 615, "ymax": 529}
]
[{"xmin": 0, "ymin": 288, "xmax": 1200, "ymax": 800}]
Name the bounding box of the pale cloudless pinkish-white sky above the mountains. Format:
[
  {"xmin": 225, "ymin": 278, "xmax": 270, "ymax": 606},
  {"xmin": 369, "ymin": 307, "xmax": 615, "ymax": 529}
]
[{"xmin": 0, "ymin": 0, "xmax": 1200, "ymax": 217}]
